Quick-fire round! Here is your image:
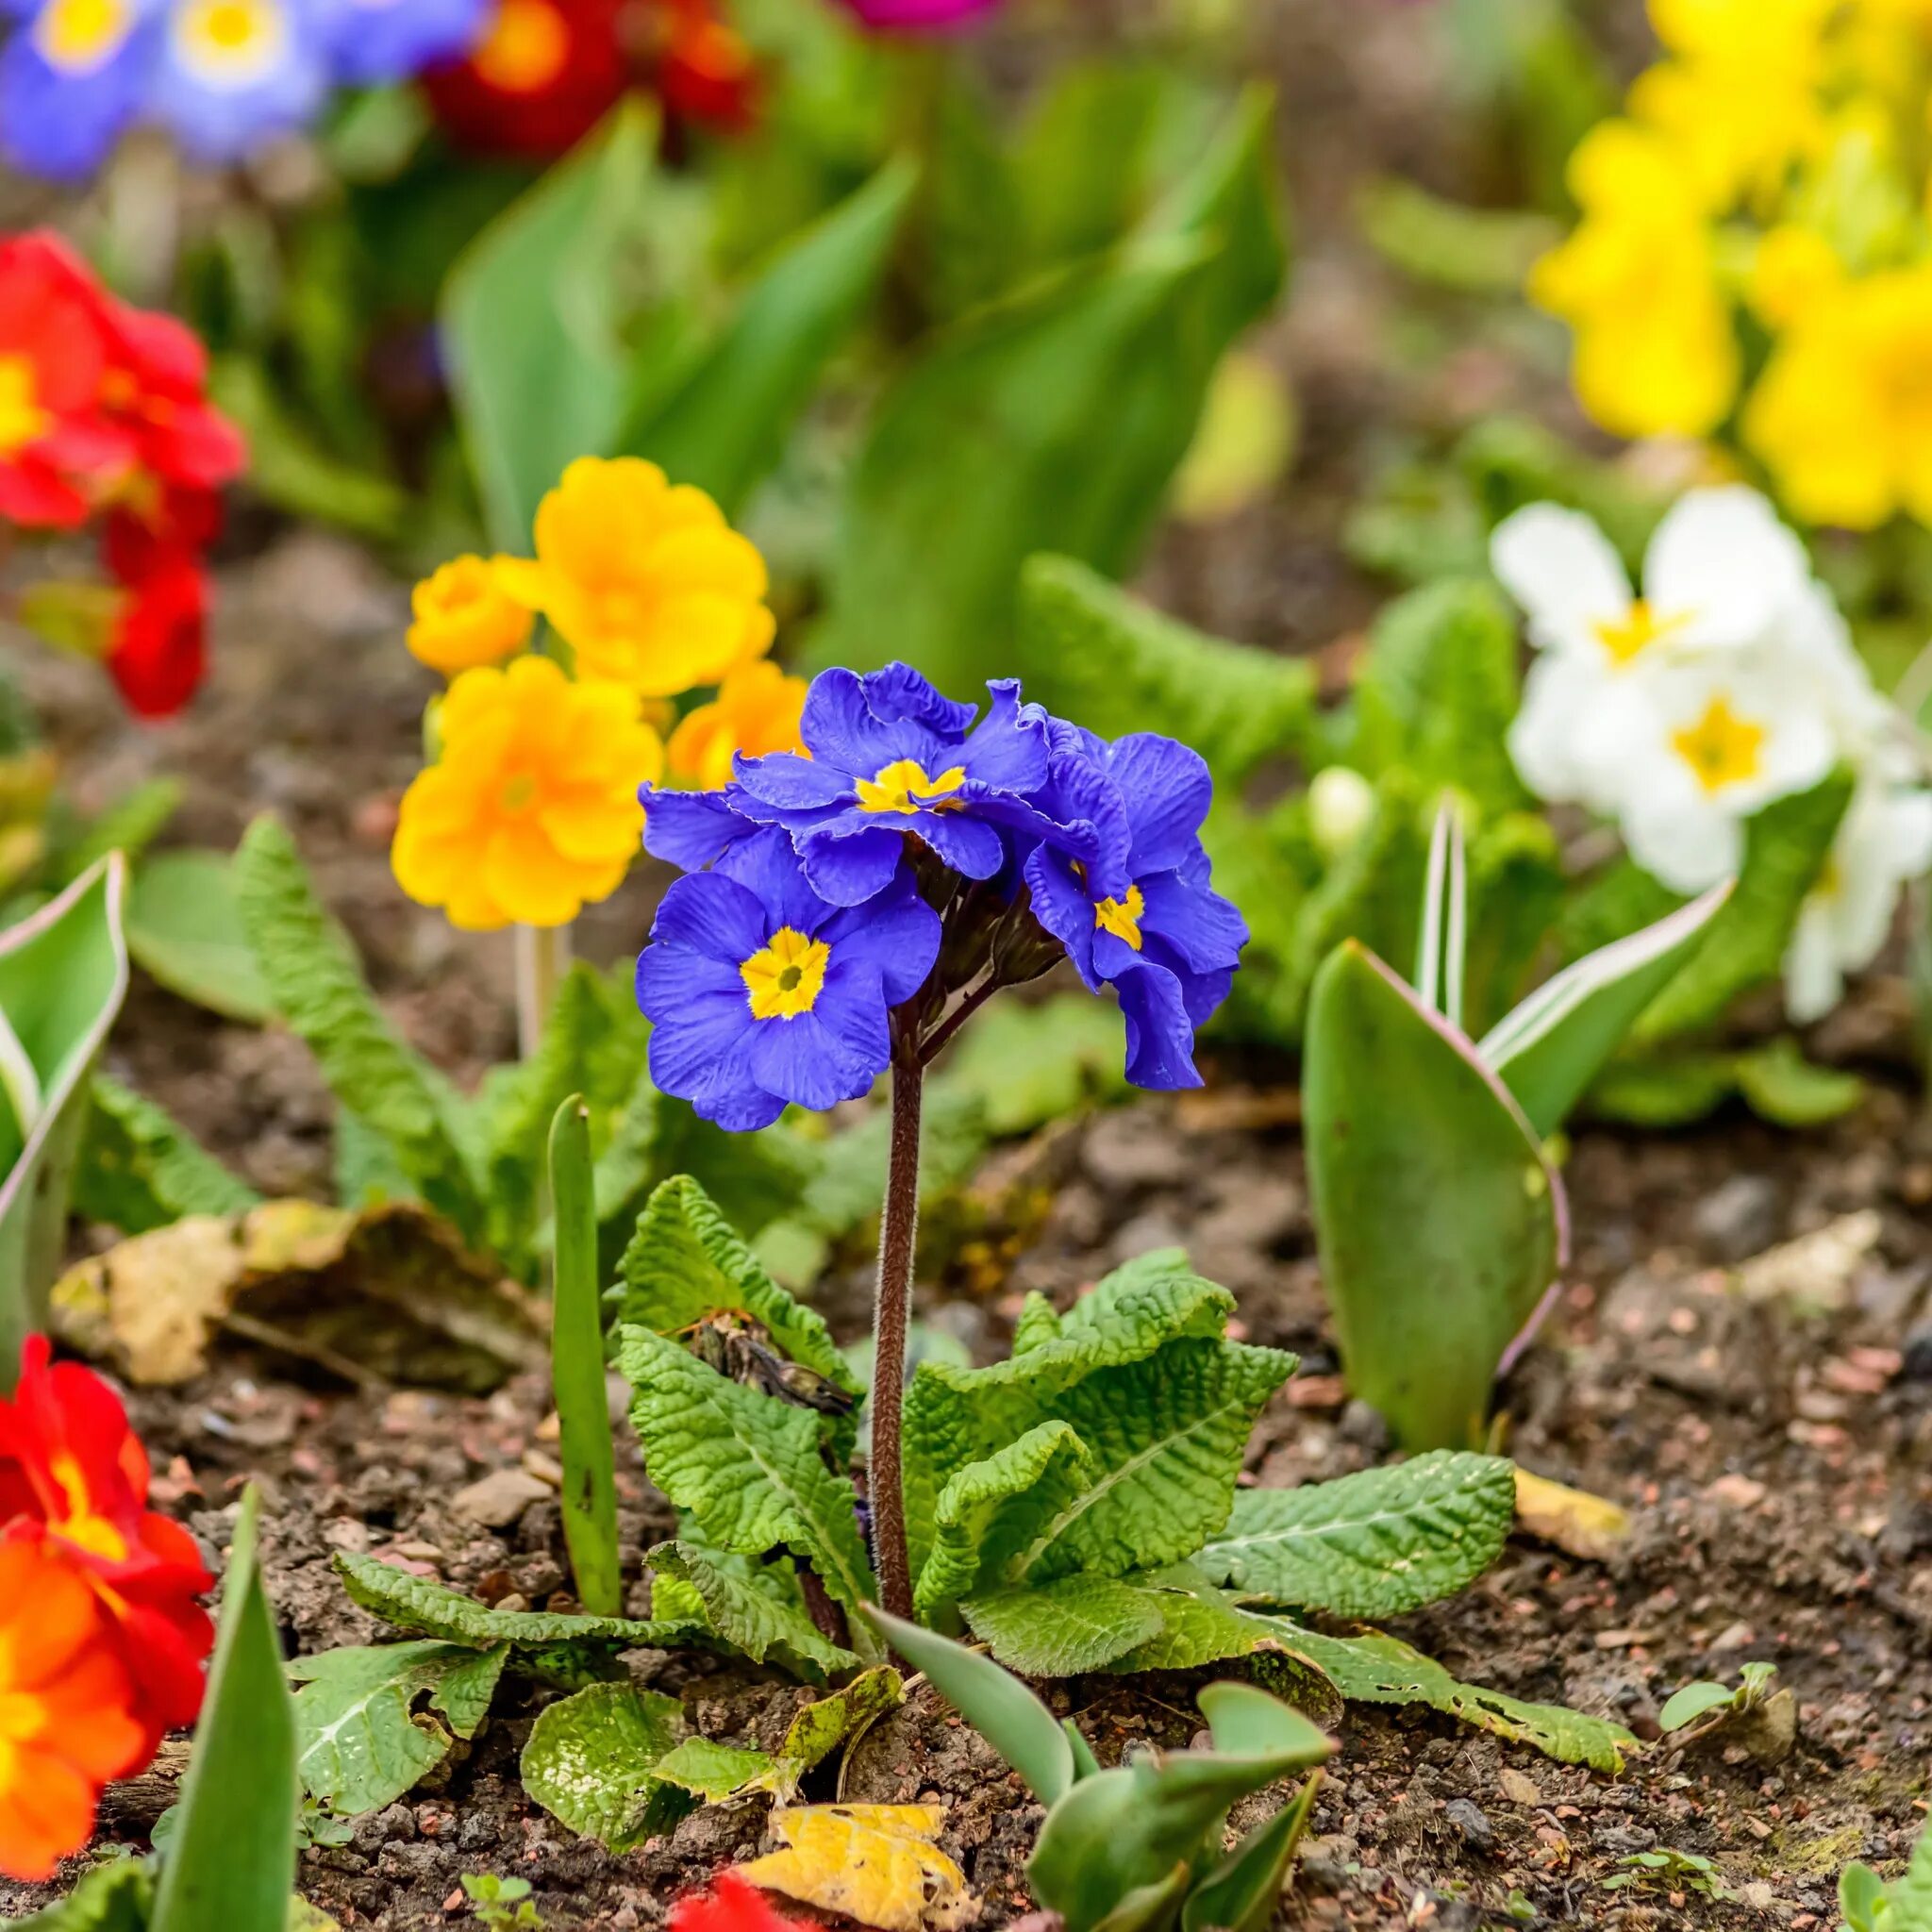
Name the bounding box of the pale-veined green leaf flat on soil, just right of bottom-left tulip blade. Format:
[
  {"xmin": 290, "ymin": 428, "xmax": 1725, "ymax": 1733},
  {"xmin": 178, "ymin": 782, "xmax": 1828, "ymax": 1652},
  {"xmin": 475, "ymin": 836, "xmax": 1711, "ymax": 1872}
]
[{"xmin": 288, "ymin": 1639, "xmax": 510, "ymax": 1818}]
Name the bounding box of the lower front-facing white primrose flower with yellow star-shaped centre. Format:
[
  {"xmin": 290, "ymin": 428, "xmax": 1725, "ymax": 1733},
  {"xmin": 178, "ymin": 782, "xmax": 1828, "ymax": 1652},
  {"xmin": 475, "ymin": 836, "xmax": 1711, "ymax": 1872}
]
[{"xmin": 1617, "ymin": 651, "xmax": 1838, "ymax": 892}]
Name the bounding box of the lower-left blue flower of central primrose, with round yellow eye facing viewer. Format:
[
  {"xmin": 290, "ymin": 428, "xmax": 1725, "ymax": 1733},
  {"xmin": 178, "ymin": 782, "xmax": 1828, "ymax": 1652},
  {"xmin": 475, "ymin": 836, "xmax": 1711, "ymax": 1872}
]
[{"xmin": 638, "ymin": 829, "xmax": 939, "ymax": 1132}]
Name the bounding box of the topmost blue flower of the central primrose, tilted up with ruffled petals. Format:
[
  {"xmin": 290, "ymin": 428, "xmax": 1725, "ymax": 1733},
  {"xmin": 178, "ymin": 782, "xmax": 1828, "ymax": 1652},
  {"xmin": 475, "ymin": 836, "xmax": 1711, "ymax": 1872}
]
[{"xmin": 732, "ymin": 665, "xmax": 1091, "ymax": 907}]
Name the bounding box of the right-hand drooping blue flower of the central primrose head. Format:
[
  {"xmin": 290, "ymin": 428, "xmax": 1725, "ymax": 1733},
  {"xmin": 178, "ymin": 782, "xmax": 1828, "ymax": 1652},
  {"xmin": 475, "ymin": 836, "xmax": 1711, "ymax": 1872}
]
[{"xmin": 1025, "ymin": 721, "xmax": 1248, "ymax": 1088}]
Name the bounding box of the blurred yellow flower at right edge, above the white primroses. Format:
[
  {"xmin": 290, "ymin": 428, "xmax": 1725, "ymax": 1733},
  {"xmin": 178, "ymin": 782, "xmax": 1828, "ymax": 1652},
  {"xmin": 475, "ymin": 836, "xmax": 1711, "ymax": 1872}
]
[{"xmin": 1744, "ymin": 263, "xmax": 1932, "ymax": 529}]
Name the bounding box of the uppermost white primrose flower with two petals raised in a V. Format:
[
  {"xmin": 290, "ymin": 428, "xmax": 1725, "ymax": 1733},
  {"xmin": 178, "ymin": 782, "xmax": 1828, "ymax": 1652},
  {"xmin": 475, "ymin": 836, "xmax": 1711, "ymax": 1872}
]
[{"xmin": 1490, "ymin": 487, "xmax": 1810, "ymax": 815}]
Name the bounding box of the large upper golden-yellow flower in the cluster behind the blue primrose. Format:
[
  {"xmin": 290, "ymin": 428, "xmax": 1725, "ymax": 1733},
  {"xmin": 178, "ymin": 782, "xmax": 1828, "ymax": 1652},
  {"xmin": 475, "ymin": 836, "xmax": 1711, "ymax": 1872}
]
[{"xmin": 502, "ymin": 456, "xmax": 776, "ymax": 697}]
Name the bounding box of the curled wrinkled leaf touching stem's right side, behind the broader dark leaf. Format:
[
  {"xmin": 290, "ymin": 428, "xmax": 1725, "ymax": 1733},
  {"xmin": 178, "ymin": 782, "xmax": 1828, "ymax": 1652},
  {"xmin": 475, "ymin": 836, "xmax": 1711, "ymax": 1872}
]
[{"xmin": 904, "ymin": 1248, "xmax": 1235, "ymax": 1574}]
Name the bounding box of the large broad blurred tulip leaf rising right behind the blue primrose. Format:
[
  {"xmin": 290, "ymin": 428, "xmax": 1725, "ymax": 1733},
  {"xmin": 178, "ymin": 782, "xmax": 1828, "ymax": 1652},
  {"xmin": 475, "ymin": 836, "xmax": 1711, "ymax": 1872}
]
[{"xmin": 811, "ymin": 92, "xmax": 1283, "ymax": 695}]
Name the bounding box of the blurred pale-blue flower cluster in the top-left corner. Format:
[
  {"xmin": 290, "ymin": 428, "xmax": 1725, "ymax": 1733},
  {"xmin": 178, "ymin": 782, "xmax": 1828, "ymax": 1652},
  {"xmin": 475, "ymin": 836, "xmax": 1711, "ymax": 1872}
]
[{"xmin": 0, "ymin": 0, "xmax": 491, "ymax": 179}]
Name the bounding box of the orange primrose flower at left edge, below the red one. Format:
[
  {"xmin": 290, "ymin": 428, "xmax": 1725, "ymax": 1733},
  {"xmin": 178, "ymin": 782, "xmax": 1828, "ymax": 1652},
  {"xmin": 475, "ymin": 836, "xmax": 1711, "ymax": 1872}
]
[{"xmin": 0, "ymin": 1534, "xmax": 151, "ymax": 1882}]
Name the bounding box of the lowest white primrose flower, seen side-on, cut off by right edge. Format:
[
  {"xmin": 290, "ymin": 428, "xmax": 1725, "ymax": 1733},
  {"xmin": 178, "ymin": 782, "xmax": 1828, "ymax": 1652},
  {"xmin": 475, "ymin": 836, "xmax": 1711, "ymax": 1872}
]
[{"xmin": 1785, "ymin": 778, "xmax": 1932, "ymax": 1025}]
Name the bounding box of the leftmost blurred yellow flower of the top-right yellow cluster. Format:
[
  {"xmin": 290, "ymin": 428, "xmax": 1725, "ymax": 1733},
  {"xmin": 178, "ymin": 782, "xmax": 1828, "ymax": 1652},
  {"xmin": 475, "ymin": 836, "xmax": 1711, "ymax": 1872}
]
[{"xmin": 1530, "ymin": 120, "xmax": 1739, "ymax": 437}]
